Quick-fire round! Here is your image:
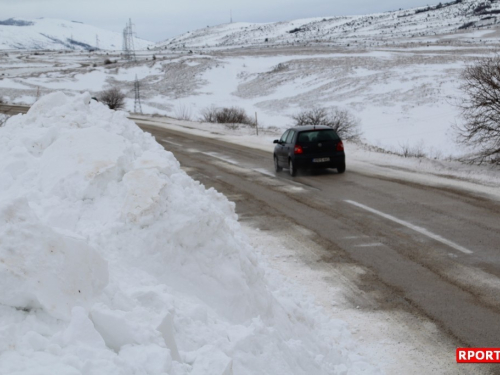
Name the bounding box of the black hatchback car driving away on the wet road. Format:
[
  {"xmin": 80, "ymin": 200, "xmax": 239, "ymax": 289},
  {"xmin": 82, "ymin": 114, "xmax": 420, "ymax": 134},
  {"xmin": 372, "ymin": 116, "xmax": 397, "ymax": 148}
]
[{"xmin": 274, "ymin": 125, "xmax": 345, "ymax": 176}]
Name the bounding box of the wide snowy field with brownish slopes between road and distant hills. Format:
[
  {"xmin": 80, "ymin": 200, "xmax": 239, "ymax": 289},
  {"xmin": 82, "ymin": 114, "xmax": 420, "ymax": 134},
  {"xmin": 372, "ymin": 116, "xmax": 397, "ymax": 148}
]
[{"xmin": 0, "ymin": 38, "xmax": 493, "ymax": 160}]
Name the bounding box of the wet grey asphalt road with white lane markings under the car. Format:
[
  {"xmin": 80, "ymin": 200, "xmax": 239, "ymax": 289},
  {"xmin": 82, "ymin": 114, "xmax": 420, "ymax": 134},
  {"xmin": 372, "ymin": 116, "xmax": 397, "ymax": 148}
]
[{"xmin": 0, "ymin": 106, "xmax": 500, "ymax": 372}]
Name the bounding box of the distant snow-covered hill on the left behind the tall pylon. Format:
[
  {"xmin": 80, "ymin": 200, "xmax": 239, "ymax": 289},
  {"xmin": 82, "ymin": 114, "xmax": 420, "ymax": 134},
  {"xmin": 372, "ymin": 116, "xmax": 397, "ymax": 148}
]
[{"xmin": 0, "ymin": 18, "xmax": 153, "ymax": 50}]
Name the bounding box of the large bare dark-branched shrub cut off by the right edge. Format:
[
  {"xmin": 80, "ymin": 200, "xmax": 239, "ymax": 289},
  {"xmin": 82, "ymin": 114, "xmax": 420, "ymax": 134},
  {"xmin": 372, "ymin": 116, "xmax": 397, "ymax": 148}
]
[{"xmin": 455, "ymin": 55, "xmax": 500, "ymax": 164}]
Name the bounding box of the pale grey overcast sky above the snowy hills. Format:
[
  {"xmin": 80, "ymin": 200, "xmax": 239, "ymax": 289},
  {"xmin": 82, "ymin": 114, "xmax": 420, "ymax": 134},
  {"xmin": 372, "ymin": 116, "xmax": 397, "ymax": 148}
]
[{"xmin": 0, "ymin": 0, "xmax": 439, "ymax": 42}]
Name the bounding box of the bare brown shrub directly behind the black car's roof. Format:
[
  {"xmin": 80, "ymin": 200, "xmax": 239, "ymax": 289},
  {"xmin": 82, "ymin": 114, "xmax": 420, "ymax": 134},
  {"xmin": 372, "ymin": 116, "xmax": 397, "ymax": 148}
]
[{"xmin": 292, "ymin": 107, "xmax": 361, "ymax": 140}]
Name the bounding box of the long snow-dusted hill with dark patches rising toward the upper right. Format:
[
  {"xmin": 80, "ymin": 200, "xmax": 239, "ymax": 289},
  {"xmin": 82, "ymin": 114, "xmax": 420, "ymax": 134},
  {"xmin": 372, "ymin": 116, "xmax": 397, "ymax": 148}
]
[{"xmin": 158, "ymin": 0, "xmax": 500, "ymax": 48}]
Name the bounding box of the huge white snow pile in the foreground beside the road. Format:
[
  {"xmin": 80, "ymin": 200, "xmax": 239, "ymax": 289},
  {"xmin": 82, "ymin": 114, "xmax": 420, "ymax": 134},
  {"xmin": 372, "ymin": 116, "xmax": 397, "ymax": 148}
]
[{"xmin": 0, "ymin": 93, "xmax": 378, "ymax": 375}]
